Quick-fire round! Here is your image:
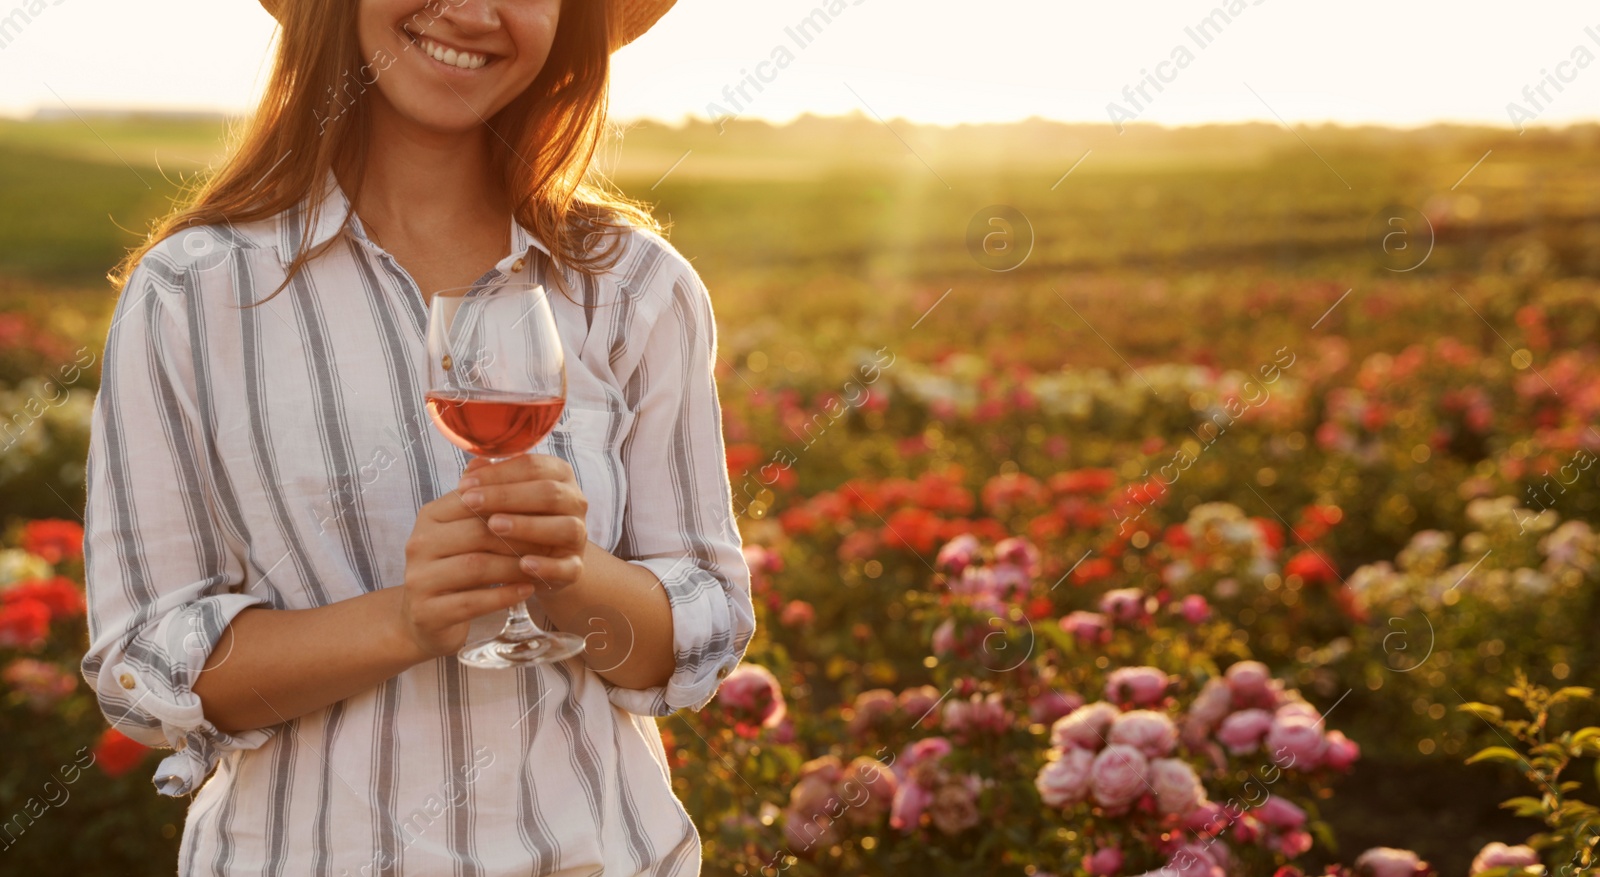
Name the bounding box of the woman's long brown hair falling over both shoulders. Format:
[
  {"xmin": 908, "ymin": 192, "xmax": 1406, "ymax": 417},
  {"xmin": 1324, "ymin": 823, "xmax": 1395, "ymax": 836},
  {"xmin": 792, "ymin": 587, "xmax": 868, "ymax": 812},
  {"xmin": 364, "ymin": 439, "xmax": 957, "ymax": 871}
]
[{"xmin": 109, "ymin": 0, "xmax": 661, "ymax": 304}]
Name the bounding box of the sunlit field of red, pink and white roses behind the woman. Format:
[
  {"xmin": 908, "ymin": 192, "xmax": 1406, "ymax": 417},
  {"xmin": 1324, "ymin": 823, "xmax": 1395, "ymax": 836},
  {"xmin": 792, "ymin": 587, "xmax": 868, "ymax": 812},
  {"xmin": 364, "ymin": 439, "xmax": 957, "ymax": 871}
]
[{"xmin": 0, "ymin": 117, "xmax": 1600, "ymax": 875}]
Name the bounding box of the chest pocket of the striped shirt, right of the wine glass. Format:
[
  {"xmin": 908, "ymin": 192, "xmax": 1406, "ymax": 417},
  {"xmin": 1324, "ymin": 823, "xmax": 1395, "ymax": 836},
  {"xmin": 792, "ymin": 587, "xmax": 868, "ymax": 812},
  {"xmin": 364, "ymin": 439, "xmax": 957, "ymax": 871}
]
[{"xmin": 541, "ymin": 400, "xmax": 634, "ymax": 552}]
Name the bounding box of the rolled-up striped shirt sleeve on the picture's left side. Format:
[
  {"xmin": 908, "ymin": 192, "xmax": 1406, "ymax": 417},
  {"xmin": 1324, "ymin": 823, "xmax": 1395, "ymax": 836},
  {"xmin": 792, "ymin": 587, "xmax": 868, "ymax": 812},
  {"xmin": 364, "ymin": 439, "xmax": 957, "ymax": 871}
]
[{"xmin": 82, "ymin": 253, "xmax": 275, "ymax": 795}]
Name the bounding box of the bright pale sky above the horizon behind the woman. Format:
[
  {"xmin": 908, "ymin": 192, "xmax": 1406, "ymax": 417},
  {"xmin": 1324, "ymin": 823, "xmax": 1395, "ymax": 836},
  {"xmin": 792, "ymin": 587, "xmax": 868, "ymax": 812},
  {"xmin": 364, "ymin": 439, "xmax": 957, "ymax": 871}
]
[{"xmin": 0, "ymin": 0, "xmax": 1600, "ymax": 128}]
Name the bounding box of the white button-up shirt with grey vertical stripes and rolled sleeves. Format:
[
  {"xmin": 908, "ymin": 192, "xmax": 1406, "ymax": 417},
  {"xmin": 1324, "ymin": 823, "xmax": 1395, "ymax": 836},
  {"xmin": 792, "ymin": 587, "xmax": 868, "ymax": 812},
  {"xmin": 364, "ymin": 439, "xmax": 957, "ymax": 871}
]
[{"xmin": 73, "ymin": 174, "xmax": 755, "ymax": 877}]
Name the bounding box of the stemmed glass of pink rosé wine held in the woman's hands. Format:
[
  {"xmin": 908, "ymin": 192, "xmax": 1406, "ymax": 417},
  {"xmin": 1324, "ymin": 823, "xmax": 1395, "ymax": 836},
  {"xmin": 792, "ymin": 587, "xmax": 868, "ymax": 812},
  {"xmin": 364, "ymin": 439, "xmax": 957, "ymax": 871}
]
[{"xmin": 427, "ymin": 275, "xmax": 584, "ymax": 667}]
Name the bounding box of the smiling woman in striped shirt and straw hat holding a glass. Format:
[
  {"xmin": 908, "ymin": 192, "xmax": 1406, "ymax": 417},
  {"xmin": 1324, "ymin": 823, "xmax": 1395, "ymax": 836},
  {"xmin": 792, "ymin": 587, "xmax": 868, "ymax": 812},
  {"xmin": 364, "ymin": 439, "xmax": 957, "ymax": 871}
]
[{"xmin": 83, "ymin": 0, "xmax": 754, "ymax": 875}]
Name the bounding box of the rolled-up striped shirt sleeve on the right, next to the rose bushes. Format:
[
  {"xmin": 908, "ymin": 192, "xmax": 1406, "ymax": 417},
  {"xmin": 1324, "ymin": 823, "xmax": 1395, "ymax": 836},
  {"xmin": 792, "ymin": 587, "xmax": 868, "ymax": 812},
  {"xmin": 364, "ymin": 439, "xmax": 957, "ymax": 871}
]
[{"xmin": 606, "ymin": 262, "xmax": 755, "ymax": 715}]
